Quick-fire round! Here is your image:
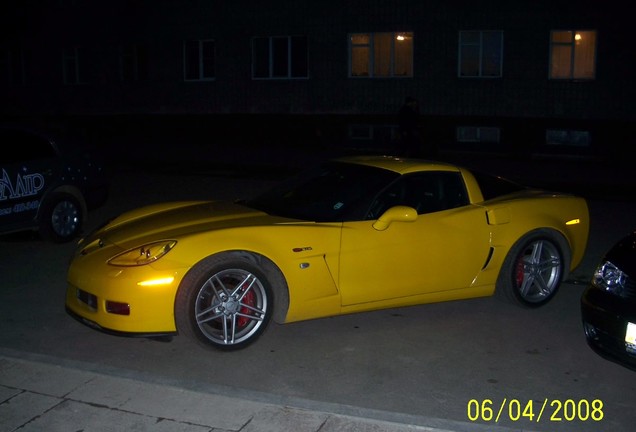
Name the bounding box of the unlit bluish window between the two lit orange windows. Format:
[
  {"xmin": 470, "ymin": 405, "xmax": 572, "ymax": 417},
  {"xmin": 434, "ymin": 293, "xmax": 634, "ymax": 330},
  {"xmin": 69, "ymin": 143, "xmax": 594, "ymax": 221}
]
[{"xmin": 459, "ymin": 31, "xmax": 503, "ymax": 78}]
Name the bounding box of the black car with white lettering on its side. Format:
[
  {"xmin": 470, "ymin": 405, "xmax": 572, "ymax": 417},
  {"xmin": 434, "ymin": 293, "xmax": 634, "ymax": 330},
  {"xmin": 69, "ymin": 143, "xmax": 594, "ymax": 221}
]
[{"xmin": 0, "ymin": 126, "xmax": 110, "ymax": 243}]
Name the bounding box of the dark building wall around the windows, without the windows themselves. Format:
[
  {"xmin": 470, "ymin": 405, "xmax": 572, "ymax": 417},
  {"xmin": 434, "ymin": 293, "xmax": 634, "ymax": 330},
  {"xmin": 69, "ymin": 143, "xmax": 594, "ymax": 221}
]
[{"xmin": 0, "ymin": 0, "xmax": 636, "ymax": 155}]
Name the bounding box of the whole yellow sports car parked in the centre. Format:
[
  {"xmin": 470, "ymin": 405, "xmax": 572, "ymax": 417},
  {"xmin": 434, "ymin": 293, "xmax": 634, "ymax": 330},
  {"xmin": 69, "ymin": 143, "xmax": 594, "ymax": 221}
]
[{"xmin": 66, "ymin": 156, "xmax": 589, "ymax": 350}]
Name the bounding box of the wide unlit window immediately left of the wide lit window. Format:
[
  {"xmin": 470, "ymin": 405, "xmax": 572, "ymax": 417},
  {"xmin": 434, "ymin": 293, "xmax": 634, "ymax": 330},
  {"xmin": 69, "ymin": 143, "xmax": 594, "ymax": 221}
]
[{"xmin": 252, "ymin": 36, "xmax": 308, "ymax": 79}]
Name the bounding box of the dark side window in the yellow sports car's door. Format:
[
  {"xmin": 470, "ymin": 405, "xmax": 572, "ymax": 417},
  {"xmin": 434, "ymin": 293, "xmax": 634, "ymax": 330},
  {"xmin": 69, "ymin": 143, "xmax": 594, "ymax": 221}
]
[{"xmin": 367, "ymin": 171, "xmax": 468, "ymax": 219}]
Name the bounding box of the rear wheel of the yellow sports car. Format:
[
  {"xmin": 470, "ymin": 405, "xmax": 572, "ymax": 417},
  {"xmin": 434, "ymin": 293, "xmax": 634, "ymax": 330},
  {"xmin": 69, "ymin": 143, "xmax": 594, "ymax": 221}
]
[{"xmin": 496, "ymin": 230, "xmax": 570, "ymax": 308}]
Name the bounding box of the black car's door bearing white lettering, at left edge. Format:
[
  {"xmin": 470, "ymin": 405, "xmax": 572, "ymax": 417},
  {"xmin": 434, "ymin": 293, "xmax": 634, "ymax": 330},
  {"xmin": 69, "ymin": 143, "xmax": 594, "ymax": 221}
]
[{"xmin": 0, "ymin": 128, "xmax": 59, "ymax": 230}]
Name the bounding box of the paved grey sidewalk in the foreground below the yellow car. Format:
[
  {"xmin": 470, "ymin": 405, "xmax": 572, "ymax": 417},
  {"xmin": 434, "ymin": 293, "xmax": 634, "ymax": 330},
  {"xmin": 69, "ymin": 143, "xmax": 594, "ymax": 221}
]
[{"xmin": 0, "ymin": 348, "xmax": 510, "ymax": 432}]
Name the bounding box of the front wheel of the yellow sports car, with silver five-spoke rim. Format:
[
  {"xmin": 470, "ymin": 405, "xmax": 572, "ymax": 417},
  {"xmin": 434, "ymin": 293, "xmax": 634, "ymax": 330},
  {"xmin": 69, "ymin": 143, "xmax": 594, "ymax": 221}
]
[{"xmin": 175, "ymin": 253, "xmax": 274, "ymax": 351}]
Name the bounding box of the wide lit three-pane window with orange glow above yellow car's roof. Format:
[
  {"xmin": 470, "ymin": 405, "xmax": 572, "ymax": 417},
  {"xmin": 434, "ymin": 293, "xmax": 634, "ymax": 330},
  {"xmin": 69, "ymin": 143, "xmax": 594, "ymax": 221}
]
[{"xmin": 349, "ymin": 32, "xmax": 413, "ymax": 78}]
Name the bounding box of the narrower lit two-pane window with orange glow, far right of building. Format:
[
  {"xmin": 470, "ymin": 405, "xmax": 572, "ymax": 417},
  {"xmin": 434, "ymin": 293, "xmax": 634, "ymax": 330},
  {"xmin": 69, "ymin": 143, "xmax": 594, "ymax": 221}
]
[{"xmin": 550, "ymin": 30, "xmax": 596, "ymax": 79}]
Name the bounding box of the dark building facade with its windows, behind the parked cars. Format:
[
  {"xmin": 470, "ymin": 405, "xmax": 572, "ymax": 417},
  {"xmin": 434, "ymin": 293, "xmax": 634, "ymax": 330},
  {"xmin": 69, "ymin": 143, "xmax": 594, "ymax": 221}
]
[{"xmin": 0, "ymin": 0, "xmax": 636, "ymax": 155}]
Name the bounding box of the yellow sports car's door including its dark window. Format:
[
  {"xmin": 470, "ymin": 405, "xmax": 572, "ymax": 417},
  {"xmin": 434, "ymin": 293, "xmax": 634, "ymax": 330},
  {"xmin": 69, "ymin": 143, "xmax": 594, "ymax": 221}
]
[{"xmin": 339, "ymin": 172, "xmax": 490, "ymax": 306}]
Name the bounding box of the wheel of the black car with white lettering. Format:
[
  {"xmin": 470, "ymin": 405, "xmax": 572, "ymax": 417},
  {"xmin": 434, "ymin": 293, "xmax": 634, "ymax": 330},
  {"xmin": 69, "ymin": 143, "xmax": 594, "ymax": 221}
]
[{"xmin": 38, "ymin": 192, "xmax": 84, "ymax": 243}]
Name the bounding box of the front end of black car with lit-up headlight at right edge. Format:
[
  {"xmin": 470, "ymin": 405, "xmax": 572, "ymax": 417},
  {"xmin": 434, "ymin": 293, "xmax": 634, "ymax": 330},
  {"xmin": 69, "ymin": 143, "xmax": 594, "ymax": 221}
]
[{"xmin": 581, "ymin": 231, "xmax": 636, "ymax": 370}]
